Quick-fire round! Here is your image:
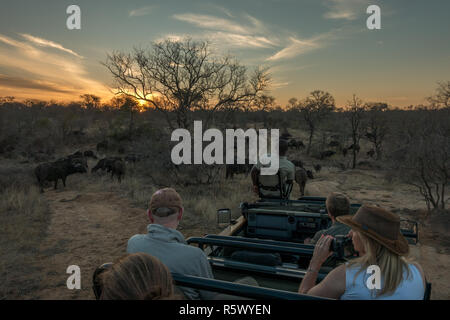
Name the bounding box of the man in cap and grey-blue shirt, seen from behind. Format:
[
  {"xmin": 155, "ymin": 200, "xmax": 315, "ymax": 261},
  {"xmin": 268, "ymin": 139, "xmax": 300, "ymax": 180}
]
[{"xmin": 127, "ymin": 188, "xmax": 214, "ymax": 299}]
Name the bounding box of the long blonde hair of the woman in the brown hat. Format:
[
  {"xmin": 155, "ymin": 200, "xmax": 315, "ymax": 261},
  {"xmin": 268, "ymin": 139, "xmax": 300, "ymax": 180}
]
[{"xmin": 349, "ymin": 230, "xmax": 410, "ymax": 296}]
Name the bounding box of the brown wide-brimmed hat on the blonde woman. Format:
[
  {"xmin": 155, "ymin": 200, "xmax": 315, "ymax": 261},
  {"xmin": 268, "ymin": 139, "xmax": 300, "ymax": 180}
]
[{"xmin": 336, "ymin": 205, "xmax": 409, "ymax": 256}]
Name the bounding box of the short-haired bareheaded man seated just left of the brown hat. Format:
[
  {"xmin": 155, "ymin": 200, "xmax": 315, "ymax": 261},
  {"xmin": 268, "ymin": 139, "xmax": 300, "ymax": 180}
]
[{"xmin": 304, "ymin": 192, "xmax": 350, "ymax": 244}]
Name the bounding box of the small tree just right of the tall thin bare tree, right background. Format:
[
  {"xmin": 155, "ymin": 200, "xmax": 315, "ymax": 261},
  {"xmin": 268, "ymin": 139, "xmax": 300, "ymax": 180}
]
[{"xmin": 366, "ymin": 103, "xmax": 388, "ymax": 160}]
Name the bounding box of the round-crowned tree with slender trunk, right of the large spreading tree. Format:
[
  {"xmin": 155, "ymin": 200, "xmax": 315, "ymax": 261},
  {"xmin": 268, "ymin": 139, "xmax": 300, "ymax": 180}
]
[{"xmin": 298, "ymin": 90, "xmax": 335, "ymax": 154}]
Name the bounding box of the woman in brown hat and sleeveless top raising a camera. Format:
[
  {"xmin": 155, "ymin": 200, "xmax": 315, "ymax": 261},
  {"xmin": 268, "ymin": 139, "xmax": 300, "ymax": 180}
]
[{"xmin": 299, "ymin": 205, "xmax": 426, "ymax": 300}]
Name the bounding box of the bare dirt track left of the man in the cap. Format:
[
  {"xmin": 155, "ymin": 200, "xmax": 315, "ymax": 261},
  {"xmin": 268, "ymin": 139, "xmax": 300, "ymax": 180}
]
[{"xmin": 25, "ymin": 191, "xmax": 147, "ymax": 299}]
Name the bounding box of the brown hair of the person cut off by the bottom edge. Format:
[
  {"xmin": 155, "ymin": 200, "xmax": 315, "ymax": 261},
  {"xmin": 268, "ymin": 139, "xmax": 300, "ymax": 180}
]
[{"xmin": 100, "ymin": 253, "xmax": 180, "ymax": 300}]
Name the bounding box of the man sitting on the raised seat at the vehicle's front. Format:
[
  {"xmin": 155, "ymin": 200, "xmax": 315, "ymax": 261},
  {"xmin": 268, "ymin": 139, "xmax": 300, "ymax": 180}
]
[{"xmin": 250, "ymin": 139, "xmax": 295, "ymax": 198}]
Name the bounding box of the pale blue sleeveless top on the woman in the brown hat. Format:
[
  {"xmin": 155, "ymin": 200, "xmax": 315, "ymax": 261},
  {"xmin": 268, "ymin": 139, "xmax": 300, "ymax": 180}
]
[{"xmin": 341, "ymin": 264, "xmax": 425, "ymax": 300}]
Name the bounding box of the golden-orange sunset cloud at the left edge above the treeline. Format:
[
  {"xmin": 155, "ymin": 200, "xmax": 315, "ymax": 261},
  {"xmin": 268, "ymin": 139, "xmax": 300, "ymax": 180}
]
[{"xmin": 0, "ymin": 34, "xmax": 111, "ymax": 100}]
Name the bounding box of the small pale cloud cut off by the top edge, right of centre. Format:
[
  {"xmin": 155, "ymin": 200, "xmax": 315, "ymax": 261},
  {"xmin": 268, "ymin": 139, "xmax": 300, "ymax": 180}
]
[{"xmin": 323, "ymin": 0, "xmax": 369, "ymax": 20}]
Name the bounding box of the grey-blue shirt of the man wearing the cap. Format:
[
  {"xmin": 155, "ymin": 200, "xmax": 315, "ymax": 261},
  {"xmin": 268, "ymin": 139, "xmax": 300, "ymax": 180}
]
[{"xmin": 127, "ymin": 224, "xmax": 214, "ymax": 299}]
